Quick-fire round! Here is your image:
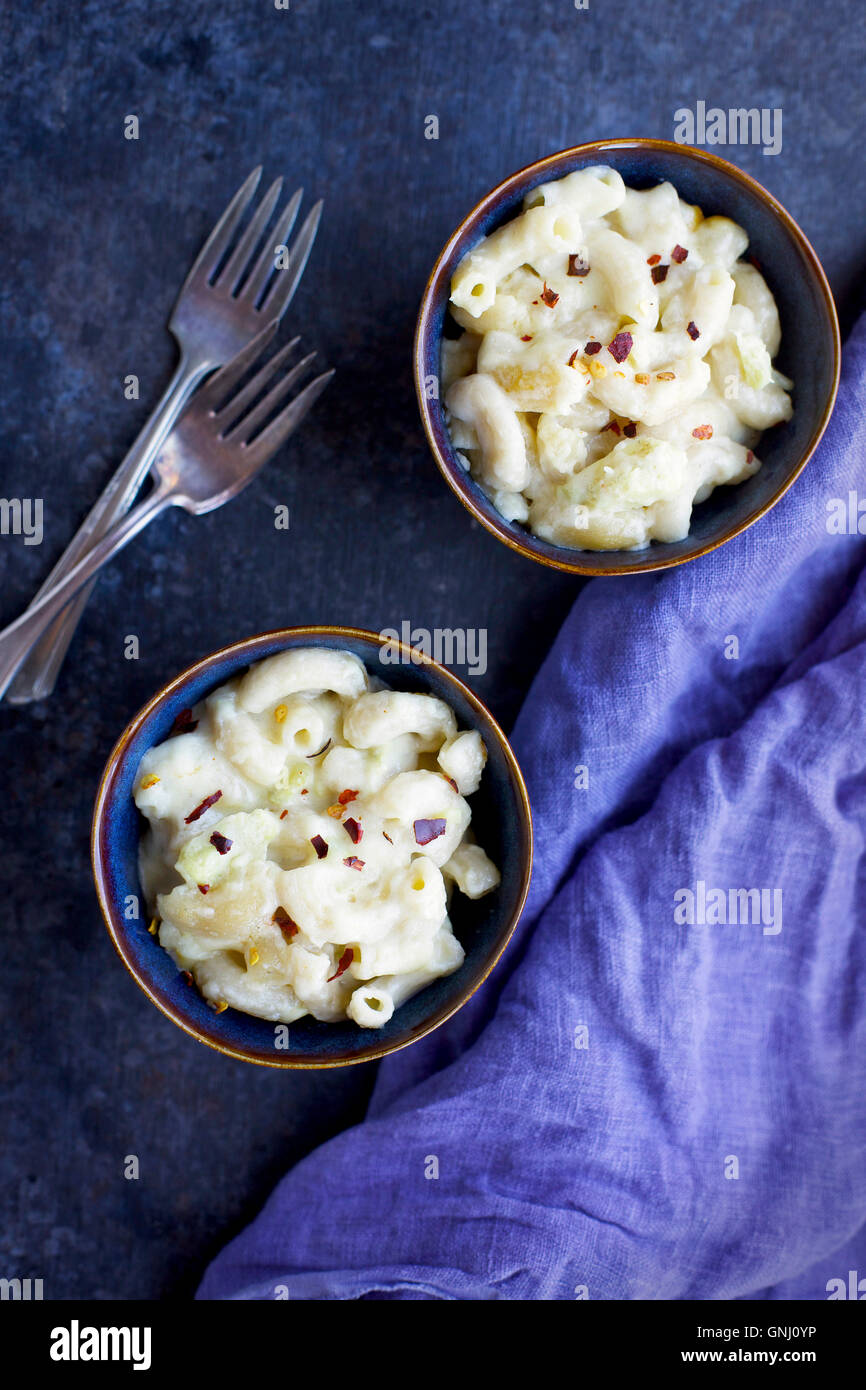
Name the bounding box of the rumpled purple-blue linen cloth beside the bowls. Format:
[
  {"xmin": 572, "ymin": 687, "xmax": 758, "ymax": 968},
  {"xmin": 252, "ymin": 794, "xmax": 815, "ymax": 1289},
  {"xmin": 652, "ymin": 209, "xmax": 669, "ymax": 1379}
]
[{"xmin": 199, "ymin": 321, "xmax": 866, "ymax": 1300}]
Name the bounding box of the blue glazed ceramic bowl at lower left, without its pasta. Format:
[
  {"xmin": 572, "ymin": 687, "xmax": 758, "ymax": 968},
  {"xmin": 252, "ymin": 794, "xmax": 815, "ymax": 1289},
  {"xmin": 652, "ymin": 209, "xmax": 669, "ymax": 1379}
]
[{"xmin": 92, "ymin": 627, "xmax": 532, "ymax": 1068}]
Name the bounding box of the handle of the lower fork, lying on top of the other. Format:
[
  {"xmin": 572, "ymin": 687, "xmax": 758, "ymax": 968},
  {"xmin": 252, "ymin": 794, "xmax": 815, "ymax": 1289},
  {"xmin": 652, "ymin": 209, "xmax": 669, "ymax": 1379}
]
[{"xmin": 0, "ymin": 484, "xmax": 172, "ymax": 699}]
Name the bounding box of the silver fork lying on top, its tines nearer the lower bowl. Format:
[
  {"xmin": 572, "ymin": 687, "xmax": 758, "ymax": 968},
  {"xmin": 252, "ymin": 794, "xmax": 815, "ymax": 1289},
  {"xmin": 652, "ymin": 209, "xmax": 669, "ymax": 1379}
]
[{"xmin": 0, "ymin": 318, "xmax": 334, "ymax": 698}]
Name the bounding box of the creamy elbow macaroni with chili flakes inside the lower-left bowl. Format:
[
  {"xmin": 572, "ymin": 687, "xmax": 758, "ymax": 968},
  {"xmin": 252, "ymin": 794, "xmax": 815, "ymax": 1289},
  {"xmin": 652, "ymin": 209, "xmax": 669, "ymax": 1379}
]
[{"xmin": 133, "ymin": 648, "xmax": 499, "ymax": 1029}]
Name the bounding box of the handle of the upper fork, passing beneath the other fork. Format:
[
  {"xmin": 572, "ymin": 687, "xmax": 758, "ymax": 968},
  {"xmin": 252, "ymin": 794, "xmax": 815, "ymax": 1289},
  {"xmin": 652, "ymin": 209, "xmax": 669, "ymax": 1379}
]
[{"xmin": 0, "ymin": 356, "xmax": 214, "ymax": 705}]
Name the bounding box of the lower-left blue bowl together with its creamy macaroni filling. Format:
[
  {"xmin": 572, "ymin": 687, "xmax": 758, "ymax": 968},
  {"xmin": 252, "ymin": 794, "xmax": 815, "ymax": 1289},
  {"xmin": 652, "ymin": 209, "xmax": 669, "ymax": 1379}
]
[{"xmin": 92, "ymin": 627, "xmax": 532, "ymax": 1068}]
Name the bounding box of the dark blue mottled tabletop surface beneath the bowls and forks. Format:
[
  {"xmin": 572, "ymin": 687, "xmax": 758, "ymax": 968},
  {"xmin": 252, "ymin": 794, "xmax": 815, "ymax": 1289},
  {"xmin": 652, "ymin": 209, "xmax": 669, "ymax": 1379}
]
[{"xmin": 0, "ymin": 0, "xmax": 866, "ymax": 1298}]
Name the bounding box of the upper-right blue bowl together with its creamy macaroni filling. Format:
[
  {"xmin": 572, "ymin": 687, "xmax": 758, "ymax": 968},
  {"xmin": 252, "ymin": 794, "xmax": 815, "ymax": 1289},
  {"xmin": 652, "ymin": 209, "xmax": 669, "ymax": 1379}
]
[{"xmin": 414, "ymin": 139, "xmax": 840, "ymax": 574}]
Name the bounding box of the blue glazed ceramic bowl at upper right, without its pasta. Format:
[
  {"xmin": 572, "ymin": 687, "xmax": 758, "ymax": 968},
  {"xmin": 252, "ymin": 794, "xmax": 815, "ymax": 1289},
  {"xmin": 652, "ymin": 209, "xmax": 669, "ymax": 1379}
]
[{"xmin": 414, "ymin": 139, "xmax": 840, "ymax": 574}]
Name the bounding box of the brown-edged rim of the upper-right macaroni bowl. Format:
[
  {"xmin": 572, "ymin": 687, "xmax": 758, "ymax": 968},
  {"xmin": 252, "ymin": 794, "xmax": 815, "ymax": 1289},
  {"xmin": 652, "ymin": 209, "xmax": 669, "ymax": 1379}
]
[{"xmin": 413, "ymin": 136, "xmax": 842, "ymax": 578}]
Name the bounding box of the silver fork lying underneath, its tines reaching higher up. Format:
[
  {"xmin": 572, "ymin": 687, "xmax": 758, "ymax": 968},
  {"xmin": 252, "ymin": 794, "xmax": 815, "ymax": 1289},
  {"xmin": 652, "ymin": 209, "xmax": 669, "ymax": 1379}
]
[{"xmin": 8, "ymin": 168, "xmax": 321, "ymax": 705}]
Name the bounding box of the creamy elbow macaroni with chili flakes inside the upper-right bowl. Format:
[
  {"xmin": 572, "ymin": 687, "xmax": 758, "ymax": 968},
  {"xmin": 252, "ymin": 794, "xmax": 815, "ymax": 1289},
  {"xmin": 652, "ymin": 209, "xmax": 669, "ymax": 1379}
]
[{"xmin": 442, "ymin": 165, "xmax": 792, "ymax": 550}]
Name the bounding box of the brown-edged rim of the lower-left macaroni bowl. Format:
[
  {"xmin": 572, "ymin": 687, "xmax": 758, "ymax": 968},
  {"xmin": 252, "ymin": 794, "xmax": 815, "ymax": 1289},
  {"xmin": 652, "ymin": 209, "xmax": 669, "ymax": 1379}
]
[{"xmin": 90, "ymin": 624, "xmax": 534, "ymax": 1072}]
